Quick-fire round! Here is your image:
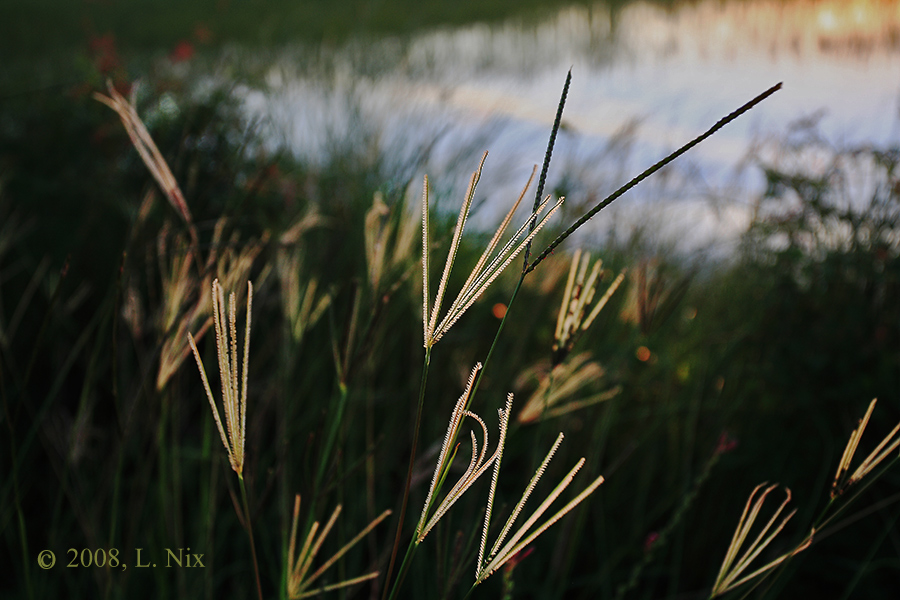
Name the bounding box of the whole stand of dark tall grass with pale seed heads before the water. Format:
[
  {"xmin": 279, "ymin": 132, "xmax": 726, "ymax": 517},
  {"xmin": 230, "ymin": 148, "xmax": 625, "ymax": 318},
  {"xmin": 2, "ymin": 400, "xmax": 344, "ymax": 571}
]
[{"xmin": 0, "ymin": 71, "xmax": 900, "ymax": 598}]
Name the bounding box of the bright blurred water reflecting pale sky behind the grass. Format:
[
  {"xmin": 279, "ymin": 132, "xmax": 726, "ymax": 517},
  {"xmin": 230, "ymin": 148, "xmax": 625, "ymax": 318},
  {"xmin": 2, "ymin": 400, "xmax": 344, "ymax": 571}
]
[{"xmin": 237, "ymin": 0, "xmax": 900, "ymax": 247}]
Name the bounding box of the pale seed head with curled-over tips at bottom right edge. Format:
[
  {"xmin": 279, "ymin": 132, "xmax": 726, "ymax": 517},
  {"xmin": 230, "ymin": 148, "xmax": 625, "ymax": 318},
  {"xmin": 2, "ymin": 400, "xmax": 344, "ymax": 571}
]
[{"xmin": 710, "ymin": 483, "xmax": 815, "ymax": 598}]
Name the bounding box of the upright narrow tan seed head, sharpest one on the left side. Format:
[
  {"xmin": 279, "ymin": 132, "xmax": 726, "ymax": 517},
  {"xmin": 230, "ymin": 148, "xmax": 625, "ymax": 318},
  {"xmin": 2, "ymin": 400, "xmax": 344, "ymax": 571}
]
[{"xmin": 188, "ymin": 279, "xmax": 253, "ymax": 476}]
